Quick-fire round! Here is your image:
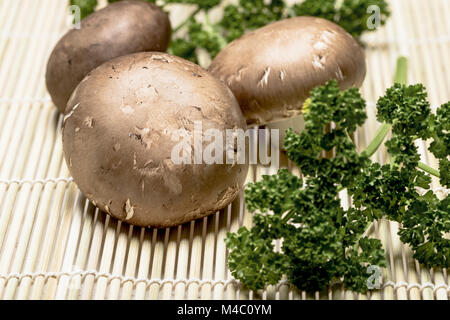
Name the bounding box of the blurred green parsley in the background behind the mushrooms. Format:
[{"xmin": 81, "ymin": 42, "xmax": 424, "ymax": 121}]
[{"xmin": 71, "ymin": 0, "xmax": 390, "ymax": 63}]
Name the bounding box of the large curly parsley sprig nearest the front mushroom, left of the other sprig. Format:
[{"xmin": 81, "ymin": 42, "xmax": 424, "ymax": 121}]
[{"xmin": 227, "ymin": 81, "xmax": 385, "ymax": 292}]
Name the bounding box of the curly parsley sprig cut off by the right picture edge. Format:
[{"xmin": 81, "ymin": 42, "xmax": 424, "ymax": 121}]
[{"xmin": 351, "ymin": 84, "xmax": 450, "ymax": 268}]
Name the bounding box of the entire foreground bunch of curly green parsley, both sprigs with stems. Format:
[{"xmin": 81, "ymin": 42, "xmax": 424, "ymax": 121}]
[{"xmin": 226, "ymin": 59, "xmax": 450, "ymax": 292}]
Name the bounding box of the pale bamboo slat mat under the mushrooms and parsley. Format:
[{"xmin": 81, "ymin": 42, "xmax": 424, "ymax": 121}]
[{"xmin": 0, "ymin": 0, "xmax": 450, "ymax": 300}]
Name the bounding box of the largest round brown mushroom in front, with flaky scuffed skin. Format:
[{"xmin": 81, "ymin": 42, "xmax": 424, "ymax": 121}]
[{"xmin": 63, "ymin": 52, "xmax": 248, "ymax": 227}]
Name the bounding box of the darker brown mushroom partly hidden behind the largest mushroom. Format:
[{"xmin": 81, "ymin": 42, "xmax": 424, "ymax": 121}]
[{"xmin": 46, "ymin": 1, "xmax": 171, "ymax": 113}]
